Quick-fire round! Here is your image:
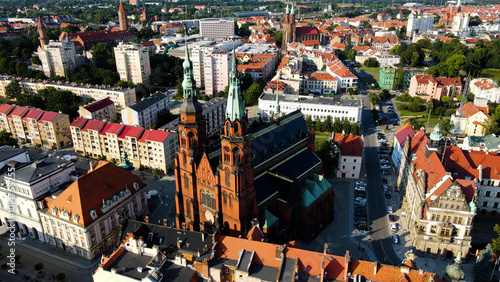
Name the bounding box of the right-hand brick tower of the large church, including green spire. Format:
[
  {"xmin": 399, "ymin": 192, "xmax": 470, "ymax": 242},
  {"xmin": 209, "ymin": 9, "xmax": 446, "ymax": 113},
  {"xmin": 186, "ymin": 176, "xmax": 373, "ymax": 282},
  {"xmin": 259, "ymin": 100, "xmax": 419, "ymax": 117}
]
[{"xmin": 218, "ymin": 48, "xmax": 258, "ymax": 236}]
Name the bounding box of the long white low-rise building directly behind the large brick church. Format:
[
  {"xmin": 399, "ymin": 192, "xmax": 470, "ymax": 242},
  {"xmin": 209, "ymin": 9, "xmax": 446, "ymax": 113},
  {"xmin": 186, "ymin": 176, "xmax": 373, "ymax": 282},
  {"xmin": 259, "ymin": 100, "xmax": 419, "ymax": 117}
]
[{"xmin": 259, "ymin": 93, "xmax": 363, "ymax": 123}]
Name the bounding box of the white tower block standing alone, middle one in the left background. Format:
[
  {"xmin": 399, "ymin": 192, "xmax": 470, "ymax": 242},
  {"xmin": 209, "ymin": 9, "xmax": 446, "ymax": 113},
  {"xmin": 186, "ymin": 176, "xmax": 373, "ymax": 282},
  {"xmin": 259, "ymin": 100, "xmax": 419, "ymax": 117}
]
[{"xmin": 114, "ymin": 42, "xmax": 151, "ymax": 84}]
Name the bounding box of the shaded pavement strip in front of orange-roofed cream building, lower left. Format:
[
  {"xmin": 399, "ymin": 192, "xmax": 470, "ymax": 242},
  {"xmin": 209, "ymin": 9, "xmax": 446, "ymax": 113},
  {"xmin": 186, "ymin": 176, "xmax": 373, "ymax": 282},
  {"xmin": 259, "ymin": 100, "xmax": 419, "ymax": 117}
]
[{"xmin": 0, "ymin": 236, "xmax": 99, "ymax": 270}]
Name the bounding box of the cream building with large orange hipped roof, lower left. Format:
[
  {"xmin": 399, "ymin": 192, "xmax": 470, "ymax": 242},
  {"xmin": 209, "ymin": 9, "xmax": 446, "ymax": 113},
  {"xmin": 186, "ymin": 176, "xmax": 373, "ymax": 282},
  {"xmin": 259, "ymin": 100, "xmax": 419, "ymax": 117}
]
[{"xmin": 38, "ymin": 161, "xmax": 148, "ymax": 260}]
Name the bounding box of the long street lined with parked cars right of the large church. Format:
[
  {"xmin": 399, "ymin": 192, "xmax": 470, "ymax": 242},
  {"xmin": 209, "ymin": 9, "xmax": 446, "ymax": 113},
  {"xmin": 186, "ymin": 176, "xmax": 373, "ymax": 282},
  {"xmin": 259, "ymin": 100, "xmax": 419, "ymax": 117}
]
[{"xmin": 360, "ymin": 93, "xmax": 401, "ymax": 265}]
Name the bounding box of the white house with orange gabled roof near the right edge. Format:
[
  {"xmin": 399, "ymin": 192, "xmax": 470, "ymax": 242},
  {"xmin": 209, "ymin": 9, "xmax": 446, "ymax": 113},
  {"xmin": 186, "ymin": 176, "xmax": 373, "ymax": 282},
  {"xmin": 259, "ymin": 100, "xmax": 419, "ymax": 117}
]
[{"xmin": 451, "ymin": 102, "xmax": 489, "ymax": 136}]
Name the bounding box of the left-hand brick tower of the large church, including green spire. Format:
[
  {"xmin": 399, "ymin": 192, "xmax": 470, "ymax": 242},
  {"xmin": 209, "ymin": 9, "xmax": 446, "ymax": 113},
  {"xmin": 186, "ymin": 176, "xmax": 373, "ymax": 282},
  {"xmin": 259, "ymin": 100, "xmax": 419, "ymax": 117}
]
[{"xmin": 175, "ymin": 41, "xmax": 207, "ymax": 230}]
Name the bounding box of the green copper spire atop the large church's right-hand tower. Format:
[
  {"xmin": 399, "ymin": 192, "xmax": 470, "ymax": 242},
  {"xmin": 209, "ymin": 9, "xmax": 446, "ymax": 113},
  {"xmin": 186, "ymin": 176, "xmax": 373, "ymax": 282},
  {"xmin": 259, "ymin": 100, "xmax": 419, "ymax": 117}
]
[{"xmin": 226, "ymin": 46, "xmax": 245, "ymax": 122}]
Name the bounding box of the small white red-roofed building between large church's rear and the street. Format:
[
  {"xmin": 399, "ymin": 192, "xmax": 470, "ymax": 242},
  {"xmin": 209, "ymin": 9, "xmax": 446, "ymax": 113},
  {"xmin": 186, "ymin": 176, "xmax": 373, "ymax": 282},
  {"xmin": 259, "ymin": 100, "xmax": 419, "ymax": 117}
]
[{"xmin": 334, "ymin": 133, "xmax": 363, "ymax": 179}]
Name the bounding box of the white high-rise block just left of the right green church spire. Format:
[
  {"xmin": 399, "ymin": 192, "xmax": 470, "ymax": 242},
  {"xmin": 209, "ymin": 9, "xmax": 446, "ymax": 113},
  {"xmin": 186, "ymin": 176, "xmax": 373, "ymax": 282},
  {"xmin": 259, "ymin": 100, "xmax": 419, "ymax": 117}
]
[{"xmin": 203, "ymin": 51, "xmax": 233, "ymax": 96}]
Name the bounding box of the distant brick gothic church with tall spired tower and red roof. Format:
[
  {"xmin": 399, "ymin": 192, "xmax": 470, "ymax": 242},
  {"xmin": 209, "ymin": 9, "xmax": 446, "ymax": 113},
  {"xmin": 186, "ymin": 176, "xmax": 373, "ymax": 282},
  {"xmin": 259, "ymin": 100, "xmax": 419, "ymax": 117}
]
[{"xmin": 281, "ymin": 5, "xmax": 321, "ymax": 53}]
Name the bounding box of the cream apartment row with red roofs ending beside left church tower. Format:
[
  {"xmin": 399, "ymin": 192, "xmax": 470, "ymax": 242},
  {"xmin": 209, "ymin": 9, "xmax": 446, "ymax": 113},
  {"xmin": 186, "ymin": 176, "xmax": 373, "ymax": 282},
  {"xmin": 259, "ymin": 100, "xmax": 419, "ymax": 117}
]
[{"xmin": 70, "ymin": 117, "xmax": 178, "ymax": 173}]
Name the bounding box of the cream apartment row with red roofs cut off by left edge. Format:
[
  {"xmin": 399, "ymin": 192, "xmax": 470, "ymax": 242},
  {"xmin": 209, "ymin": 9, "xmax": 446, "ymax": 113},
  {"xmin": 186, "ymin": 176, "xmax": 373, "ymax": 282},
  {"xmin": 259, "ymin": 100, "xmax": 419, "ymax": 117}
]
[{"xmin": 0, "ymin": 105, "xmax": 71, "ymax": 149}]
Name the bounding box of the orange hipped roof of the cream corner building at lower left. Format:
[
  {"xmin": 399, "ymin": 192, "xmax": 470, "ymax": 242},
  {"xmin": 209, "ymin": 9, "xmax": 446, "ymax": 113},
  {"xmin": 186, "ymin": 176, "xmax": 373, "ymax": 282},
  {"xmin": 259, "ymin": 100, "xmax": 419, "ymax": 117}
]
[{"xmin": 45, "ymin": 161, "xmax": 145, "ymax": 226}]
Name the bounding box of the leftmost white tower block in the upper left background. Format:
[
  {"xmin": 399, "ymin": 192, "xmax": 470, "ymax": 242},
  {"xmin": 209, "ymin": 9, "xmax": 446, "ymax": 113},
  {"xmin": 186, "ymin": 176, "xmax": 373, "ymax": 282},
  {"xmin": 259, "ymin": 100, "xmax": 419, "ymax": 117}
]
[{"xmin": 38, "ymin": 40, "xmax": 77, "ymax": 77}]
